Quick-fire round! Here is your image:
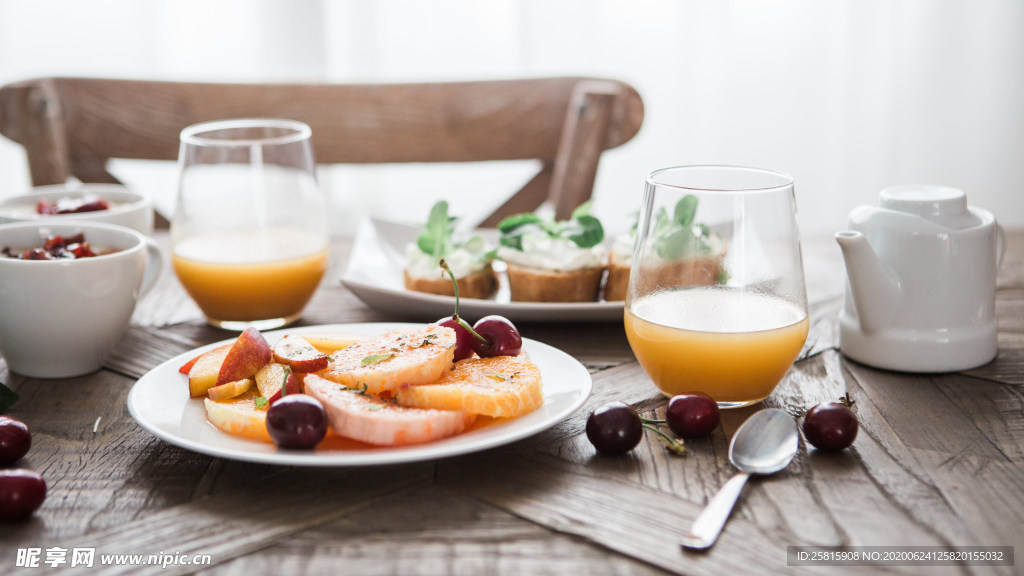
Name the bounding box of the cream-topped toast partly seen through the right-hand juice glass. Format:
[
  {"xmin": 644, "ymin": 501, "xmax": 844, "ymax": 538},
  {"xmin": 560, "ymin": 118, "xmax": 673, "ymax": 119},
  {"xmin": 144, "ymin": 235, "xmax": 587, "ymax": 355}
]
[{"xmin": 604, "ymin": 195, "xmax": 729, "ymax": 300}]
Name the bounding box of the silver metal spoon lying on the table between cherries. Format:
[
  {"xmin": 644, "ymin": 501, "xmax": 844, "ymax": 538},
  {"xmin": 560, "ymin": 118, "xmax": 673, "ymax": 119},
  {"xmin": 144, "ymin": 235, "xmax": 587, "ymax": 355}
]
[{"xmin": 683, "ymin": 408, "xmax": 800, "ymax": 549}]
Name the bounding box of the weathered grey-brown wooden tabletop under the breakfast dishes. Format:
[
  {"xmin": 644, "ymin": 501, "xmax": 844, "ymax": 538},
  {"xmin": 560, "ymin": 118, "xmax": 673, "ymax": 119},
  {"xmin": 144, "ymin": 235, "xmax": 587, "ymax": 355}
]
[{"xmin": 0, "ymin": 233, "xmax": 1024, "ymax": 575}]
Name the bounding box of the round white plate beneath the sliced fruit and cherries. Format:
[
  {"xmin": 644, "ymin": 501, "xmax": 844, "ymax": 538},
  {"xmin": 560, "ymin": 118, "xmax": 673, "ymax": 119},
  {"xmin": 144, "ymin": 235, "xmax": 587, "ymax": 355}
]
[{"xmin": 128, "ymin": 323, "xmax": 592, "ymax": 466}]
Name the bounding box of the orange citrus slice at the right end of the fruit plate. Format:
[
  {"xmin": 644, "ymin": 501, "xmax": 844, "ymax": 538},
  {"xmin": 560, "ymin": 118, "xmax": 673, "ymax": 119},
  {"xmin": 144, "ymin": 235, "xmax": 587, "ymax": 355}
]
[{"xmin": 395, "ymin": 353, "xmax": 544, "ymax": 418}]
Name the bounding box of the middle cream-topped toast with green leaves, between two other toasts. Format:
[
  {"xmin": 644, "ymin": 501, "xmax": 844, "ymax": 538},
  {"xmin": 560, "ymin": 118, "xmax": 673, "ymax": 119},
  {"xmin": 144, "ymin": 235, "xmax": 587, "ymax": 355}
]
[{"xmin": 498, "ymin": 202, "xmax": 605, "ymax": 302}]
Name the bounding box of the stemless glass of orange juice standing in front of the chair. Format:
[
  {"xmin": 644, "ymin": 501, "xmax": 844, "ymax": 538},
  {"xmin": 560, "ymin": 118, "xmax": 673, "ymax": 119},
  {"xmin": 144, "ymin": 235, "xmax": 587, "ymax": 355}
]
[{"xmin": 171, "ymin": 119, "xmax": 328, "ymax": 330}]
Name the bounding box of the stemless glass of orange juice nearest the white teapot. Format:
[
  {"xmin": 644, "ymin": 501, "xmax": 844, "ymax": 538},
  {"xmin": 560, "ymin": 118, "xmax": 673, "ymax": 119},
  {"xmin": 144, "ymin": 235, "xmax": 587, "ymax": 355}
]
[{"xmin": 625, "ymin": 166, "xmax": 809, "ymax": 408}]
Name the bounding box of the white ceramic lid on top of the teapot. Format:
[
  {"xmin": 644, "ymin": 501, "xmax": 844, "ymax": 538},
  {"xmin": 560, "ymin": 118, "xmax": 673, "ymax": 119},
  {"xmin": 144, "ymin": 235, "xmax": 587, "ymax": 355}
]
[{"xmin": 879, "ymin": 184, "xmax": 981, "ymax": 230}]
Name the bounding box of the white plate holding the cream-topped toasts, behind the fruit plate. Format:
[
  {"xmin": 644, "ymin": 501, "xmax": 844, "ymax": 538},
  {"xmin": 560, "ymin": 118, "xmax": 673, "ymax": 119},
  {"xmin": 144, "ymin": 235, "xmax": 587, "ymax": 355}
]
[{"xmin": 341, "ymin": 218, "xmax": 623, "ymax": 322}]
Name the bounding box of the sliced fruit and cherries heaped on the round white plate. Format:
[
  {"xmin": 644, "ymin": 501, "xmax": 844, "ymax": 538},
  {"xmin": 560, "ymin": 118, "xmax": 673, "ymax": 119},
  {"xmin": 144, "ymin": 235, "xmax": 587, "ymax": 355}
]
[{"xmin": 179, "ymin": 265, "xmax": 544, "ymax": 448}]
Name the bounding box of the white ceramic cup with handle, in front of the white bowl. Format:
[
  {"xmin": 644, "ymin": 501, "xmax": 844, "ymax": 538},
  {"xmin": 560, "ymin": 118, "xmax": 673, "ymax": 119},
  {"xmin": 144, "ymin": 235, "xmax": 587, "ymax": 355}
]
[{"xmin": 0, "ymin": 220, "xmax": 163, "ymax": 378}]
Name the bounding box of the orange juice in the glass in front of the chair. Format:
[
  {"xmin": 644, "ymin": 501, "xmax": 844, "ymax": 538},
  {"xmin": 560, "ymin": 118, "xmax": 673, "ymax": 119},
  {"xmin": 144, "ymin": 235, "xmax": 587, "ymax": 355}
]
[{"xmin": 171, "ymin": 229, "xmax": 328, "ymax": 322}]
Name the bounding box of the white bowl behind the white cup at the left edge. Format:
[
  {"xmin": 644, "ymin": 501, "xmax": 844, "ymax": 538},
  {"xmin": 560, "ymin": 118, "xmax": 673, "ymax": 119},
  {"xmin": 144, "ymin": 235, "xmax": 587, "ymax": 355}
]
[{"xmin": 0, "ymin": 184, "xmax": 153, "ymax": 236}]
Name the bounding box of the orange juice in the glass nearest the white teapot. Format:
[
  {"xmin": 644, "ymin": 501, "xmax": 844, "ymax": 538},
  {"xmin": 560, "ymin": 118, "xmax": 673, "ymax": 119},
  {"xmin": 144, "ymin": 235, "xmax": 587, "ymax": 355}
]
[{"xmin": 626, "ymin": 287, "xmax": 810, "ymax": 406}]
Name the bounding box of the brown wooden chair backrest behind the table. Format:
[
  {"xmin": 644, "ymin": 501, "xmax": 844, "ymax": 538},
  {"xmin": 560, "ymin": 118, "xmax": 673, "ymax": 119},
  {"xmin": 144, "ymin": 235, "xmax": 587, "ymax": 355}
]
[{"xmin": 0, "ymin": 78, "xmax": 643, "ymax": 227}]
